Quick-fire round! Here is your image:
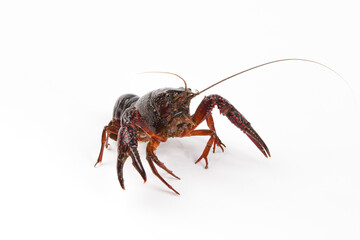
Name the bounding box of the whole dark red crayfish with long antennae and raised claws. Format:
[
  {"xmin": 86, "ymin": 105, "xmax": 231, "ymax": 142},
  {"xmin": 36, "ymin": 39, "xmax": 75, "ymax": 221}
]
[{"xmin": 95, "ymin": 59, "xmax": 334, "ymax": 194}]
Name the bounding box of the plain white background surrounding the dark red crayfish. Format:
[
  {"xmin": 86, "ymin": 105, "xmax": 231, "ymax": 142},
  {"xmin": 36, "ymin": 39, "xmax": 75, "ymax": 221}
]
[{"xmin": 0, "ymin": 0, "xmax": 360, "ymax": 239}]
